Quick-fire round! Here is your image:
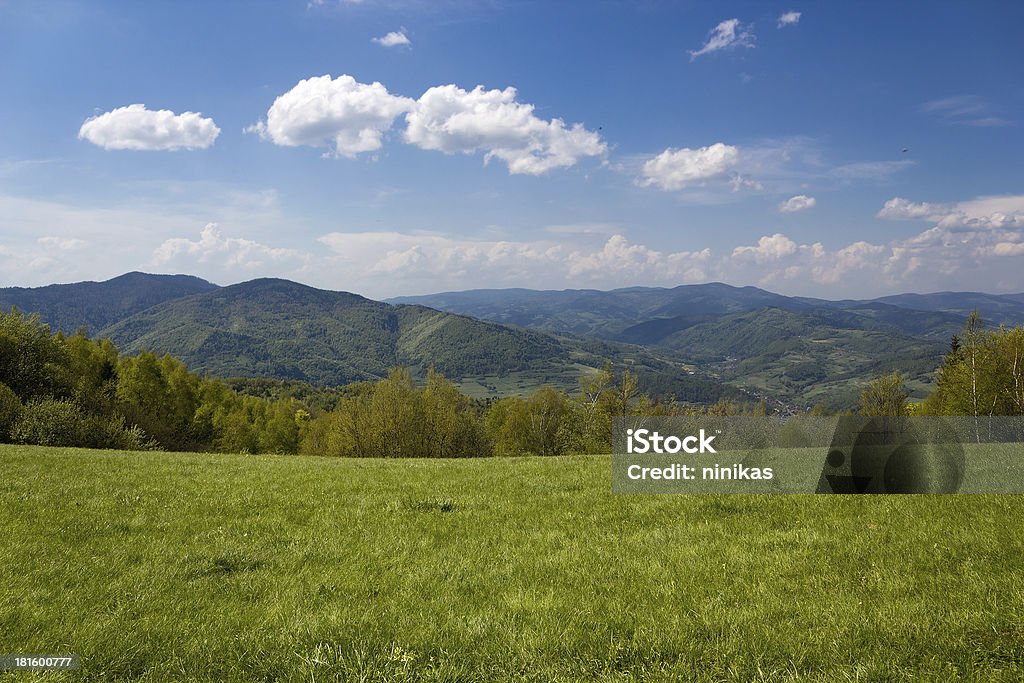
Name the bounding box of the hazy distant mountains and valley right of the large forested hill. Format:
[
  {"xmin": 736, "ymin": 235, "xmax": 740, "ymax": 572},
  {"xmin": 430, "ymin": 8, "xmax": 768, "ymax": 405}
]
[{"xmin": 393, "ymin": 283, "xmax": 1024, "ymax": 408}]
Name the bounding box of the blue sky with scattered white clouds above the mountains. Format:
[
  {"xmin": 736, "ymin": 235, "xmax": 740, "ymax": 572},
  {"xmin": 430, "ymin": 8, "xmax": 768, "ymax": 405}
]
[{"xmin": 0, "ymin": 0, "xmax": 1024, "ymax": 298}]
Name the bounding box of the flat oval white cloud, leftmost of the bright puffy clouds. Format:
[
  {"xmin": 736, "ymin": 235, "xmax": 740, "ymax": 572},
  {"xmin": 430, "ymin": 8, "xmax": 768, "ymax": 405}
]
[{"xmin": 78, "ymin": 104, "xmax": 220, "ymax": 151}]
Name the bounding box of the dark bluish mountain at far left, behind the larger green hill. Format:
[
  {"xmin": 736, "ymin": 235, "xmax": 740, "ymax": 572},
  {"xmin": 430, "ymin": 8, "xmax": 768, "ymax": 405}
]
[{"xmin": 0, "ymin": 272, "xmax": 217, "ymax": 334}]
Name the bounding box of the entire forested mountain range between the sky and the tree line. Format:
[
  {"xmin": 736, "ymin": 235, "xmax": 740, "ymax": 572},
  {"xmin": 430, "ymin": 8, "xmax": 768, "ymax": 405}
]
[{"xmin": 0, "ymin": 272, "xmax": 1024, "ymax": 408}]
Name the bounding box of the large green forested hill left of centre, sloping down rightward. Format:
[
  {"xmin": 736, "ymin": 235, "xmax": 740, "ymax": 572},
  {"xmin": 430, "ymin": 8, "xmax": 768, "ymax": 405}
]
[{"xmin": 99, "ymin": 280, "xmax": 739, "ymax": 400}]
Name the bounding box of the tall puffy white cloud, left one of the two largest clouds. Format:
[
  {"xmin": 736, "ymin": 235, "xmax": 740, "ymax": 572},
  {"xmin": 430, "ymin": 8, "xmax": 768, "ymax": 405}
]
[{"xmin": 246, "ymin": 74, "xmax": 414, "ymax": 158}]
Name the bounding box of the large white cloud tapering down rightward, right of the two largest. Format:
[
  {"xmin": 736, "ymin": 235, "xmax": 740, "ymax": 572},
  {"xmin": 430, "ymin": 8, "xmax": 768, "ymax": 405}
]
[{"xmin": 406, "ymin": 85, "xmax": 607, "ymax": 175}]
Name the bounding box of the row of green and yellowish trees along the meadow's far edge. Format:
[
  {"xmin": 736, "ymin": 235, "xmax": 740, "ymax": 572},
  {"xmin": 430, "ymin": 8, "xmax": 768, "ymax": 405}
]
[{"xmin": 0, "ymin": 310, "xmax": 1024, "ymax": 458}]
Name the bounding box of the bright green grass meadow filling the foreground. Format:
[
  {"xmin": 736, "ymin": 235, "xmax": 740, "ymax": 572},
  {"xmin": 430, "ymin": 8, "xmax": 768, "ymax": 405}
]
[{"xmin": 0, "ymin": 446, "xmax": 1024, "ymax": 682}]
